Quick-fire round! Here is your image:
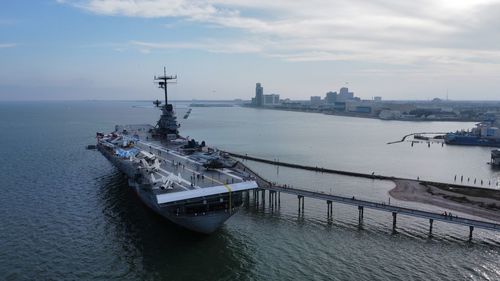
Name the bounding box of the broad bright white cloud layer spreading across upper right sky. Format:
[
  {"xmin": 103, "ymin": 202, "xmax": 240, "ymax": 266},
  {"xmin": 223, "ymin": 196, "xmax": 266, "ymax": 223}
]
[{"xmin": 60, "ymin": 0, "xmax": 500, "ymax": 68}]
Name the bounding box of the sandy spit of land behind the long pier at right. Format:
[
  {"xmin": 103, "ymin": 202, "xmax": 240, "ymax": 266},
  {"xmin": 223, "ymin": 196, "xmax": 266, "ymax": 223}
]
[{"xmin": 389, "ymin": 179, "xmax": 500, "ymax": 222}]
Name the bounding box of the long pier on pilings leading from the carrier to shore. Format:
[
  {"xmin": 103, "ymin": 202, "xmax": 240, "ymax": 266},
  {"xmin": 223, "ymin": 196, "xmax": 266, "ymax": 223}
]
[{"xmin": 238, "ymin": 162, "xmax": 500, "ymax": 240}]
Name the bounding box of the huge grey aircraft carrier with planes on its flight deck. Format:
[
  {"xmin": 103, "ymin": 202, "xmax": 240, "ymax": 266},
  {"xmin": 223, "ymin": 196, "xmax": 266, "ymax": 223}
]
[{"xmin": 96, "ymin": 69, "xmax": 258, "ymax": 234}]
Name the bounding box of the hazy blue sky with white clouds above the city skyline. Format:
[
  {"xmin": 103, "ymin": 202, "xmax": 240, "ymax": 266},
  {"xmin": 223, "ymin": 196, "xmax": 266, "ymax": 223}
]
[{"xmin": 0, "ymin": 0, "xmax": 500, "ymax": 100}]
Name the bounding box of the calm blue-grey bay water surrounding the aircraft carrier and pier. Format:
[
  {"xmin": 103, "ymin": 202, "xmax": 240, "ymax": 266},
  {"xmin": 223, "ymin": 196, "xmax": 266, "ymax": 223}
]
[{"xmin": 0, "ymin": 102, "xmax": 500, "ymax": 280}]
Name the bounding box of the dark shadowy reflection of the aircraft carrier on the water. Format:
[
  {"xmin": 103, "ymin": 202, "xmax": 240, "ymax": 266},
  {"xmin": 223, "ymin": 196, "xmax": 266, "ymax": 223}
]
[{"xmin": 98, "ymin": 173, "xmax": 252, "ymax": 280}]
